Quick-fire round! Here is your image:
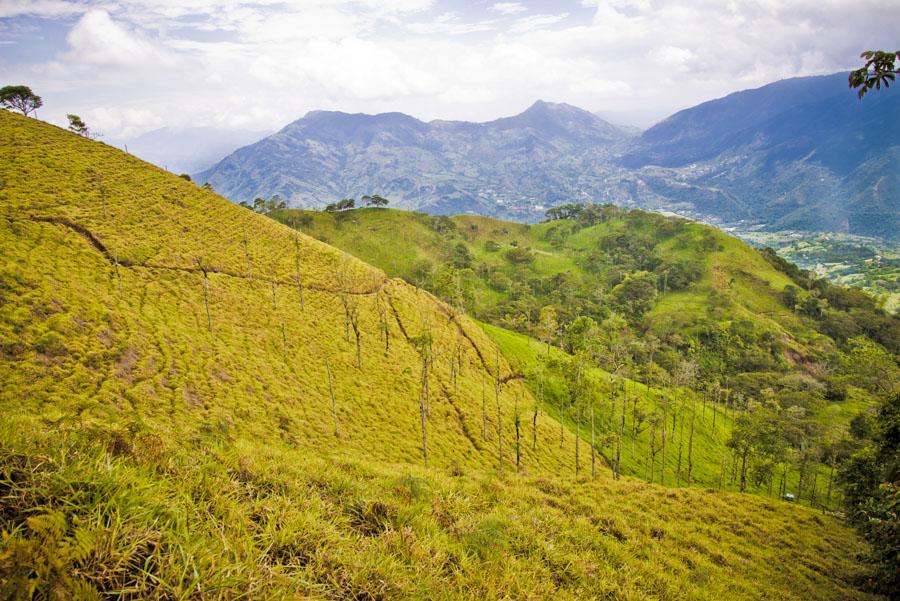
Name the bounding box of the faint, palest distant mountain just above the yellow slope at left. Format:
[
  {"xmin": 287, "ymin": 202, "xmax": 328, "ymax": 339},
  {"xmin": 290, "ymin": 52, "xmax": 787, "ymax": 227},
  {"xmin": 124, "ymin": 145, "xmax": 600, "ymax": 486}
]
[{"xmin": 109, "ymin": 127, "xmax": 268, "ymax": 173}]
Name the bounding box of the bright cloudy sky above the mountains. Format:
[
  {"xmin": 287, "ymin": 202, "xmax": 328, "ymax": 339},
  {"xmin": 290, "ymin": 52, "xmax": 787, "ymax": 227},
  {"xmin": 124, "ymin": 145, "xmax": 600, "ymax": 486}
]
[{"xmin": 0, "ymin": 0, "xmax": 900, "ymax": 138}]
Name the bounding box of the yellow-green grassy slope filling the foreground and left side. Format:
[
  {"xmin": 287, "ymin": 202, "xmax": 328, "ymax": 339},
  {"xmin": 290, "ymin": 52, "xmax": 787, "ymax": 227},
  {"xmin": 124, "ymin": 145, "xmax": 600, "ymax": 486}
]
[{"xmin": 0, "ymin": 112, "xmax": 880, "ymax": 599}]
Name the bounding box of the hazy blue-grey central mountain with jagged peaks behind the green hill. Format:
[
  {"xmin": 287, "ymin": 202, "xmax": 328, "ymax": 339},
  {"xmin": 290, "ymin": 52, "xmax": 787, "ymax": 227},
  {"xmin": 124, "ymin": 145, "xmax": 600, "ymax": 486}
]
[{"xmin": 196, "ymin": 101, "xmax": 631, "ymax": 216}]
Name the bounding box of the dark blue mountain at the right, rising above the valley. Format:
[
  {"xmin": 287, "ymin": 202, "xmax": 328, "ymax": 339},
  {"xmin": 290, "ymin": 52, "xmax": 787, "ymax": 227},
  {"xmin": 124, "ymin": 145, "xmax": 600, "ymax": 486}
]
[{"xmin": 620, "ymin": 74, "xmax": 900, "ymax": 237}]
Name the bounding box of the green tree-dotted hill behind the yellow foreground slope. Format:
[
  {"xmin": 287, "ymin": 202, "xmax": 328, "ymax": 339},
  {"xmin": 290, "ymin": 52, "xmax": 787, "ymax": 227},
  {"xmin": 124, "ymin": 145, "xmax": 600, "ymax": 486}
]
[{"xmin": 271, "ymin": 206, "xmax": 900, "ymax": 508}]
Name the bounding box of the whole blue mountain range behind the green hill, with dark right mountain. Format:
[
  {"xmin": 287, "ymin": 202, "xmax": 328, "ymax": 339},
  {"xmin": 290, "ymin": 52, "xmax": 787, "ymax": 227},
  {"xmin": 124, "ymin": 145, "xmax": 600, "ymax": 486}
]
[{"xmin": 196, "ymin": 73, "xmax": 900, "ymax": 238}]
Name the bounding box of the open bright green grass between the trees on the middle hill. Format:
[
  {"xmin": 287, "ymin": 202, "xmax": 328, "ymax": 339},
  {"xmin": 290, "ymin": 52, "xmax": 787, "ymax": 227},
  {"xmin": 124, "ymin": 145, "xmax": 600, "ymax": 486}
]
[{"xmin": 274, "ymin": 209, "xmax": 873, "ymax": 508}]
